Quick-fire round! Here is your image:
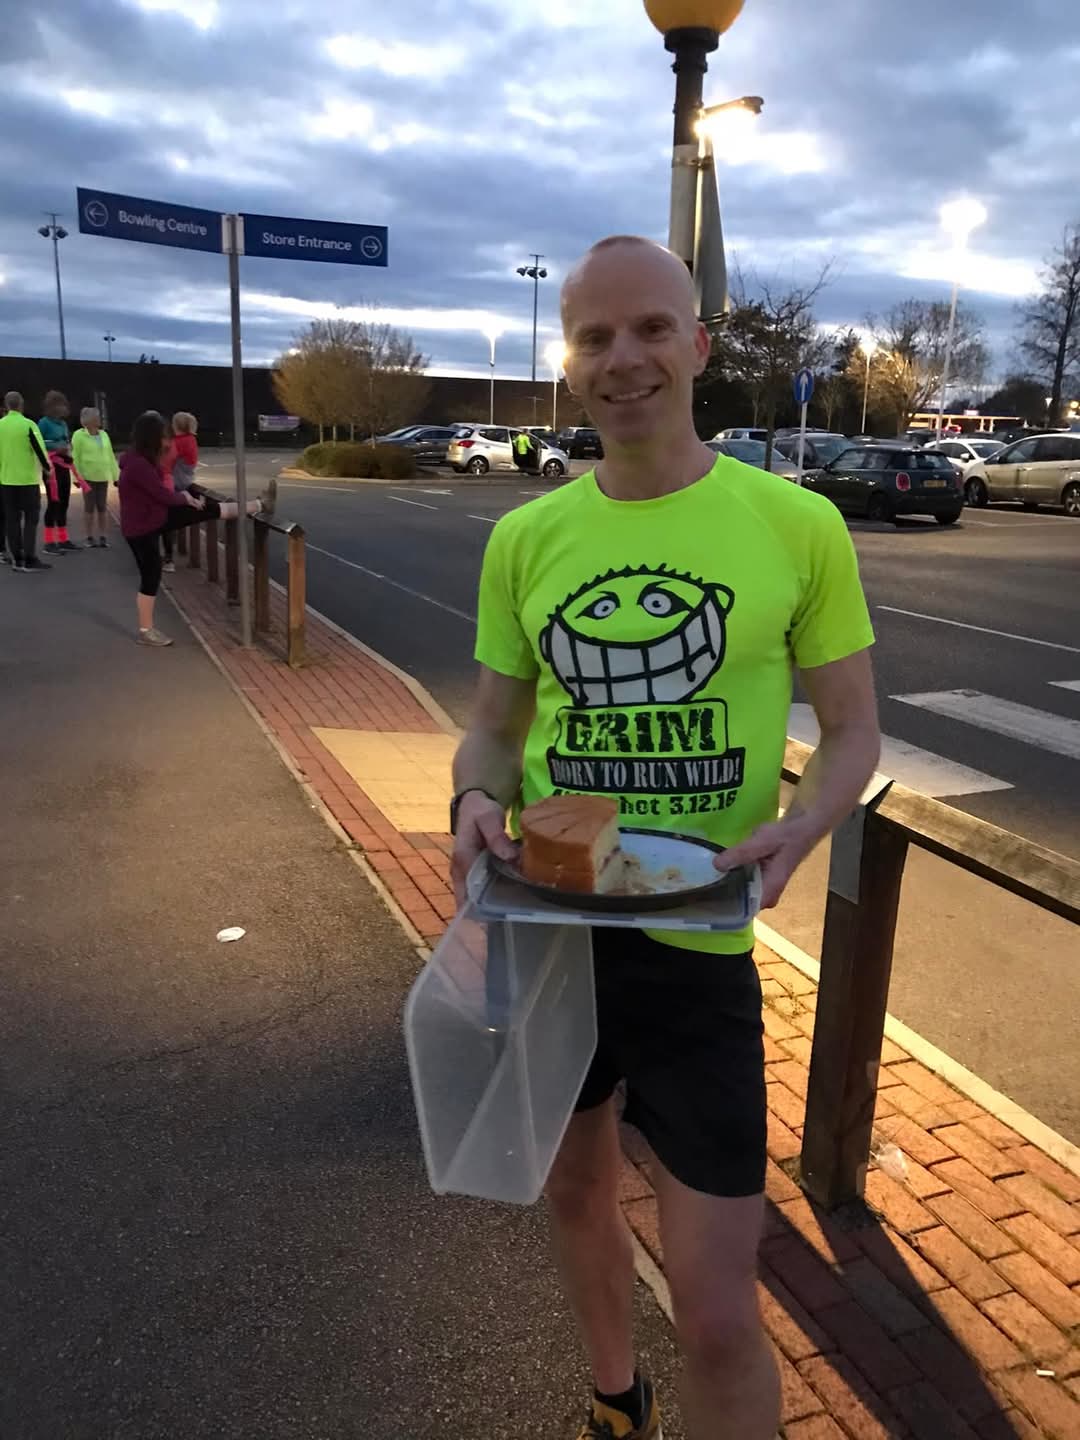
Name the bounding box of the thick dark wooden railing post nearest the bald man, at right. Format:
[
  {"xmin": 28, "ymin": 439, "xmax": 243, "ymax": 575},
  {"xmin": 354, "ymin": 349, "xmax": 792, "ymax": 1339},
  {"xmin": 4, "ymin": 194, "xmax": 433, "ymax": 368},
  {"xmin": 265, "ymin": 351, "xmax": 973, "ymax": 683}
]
[{"xmin": 802, "ymin": 791, "xmax": 907, "ymax": 1210}]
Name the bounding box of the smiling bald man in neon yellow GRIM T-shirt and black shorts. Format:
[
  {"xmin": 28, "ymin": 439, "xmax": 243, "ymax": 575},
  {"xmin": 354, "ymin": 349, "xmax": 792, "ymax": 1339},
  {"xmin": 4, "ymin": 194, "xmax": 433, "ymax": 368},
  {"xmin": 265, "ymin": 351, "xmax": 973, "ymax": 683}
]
[{"xmin": 452, "ymin": 236, "xmax": 880, "ymax": 1440}]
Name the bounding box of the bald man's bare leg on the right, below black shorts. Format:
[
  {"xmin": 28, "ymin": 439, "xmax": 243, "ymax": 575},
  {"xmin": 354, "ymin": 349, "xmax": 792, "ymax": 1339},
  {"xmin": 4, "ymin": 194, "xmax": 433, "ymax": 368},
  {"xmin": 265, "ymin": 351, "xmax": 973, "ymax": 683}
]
[{"xmin": 652, "ymin": 1162, "xmax": 780, "ymax": 1440}]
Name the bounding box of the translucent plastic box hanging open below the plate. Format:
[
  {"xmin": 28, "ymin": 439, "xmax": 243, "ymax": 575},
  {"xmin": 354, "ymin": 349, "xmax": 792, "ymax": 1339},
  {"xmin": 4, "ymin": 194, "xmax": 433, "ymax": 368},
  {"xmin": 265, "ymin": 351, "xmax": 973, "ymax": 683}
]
[{"xmin": 405, "ymin": 906, "xmax": 596, "ymax": 1205}]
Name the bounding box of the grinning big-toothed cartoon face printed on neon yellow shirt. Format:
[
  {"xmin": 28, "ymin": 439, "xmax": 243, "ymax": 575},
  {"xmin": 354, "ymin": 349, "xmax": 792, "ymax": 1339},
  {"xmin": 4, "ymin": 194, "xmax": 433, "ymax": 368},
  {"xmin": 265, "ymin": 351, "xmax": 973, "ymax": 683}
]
[{"xmin": 540, "ymin": 566, "xmax": 734, "ymax": 708}]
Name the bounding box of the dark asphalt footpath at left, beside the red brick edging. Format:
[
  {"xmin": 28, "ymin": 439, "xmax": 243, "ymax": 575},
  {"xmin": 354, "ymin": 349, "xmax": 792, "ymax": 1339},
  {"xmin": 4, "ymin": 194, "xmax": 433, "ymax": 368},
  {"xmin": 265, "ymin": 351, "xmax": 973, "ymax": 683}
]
[{"xmin": 0, "ymin": 547, "xmax": 683, "ymax": 1440}]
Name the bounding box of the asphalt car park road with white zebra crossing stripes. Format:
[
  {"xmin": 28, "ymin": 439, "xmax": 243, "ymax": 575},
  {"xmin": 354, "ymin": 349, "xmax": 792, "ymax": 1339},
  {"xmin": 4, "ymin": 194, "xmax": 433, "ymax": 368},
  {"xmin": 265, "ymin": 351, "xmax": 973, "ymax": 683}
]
[{"xmin": 201, "ymin": 458, "xmax": 1080, "ymax": 1142}]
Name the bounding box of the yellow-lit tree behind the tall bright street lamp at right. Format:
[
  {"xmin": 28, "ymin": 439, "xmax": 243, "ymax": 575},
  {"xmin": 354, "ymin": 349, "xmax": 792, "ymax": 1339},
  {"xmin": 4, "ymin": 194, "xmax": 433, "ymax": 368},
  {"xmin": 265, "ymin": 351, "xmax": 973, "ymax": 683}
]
[{"xmin": 870, "ymin": 300, "xmax": 986, "ymax": 433}]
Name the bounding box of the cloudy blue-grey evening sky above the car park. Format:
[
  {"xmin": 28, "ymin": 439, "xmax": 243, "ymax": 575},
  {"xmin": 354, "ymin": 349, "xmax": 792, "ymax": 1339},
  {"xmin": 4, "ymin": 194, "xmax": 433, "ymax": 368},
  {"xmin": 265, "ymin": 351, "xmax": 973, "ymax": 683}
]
[{"xmin": 0, "ymin": 0, "xmax": 1080, "ymax": 376}]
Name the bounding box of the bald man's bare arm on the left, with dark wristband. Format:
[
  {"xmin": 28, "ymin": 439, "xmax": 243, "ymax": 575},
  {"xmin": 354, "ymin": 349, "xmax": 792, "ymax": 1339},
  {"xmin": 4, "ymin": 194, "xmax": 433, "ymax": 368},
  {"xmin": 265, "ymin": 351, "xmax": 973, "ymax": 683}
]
[{"xmin": 452, "ymin": 665, "xmax": 536, "ymax": 904}]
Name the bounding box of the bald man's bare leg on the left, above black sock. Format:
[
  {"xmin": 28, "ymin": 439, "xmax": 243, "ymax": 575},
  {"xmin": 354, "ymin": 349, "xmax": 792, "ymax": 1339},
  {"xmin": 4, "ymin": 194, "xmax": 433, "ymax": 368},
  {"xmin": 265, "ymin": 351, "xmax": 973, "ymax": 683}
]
[{"xmin": 547, "ymin": 1100, "xmax": 639, "ymax": 1393}]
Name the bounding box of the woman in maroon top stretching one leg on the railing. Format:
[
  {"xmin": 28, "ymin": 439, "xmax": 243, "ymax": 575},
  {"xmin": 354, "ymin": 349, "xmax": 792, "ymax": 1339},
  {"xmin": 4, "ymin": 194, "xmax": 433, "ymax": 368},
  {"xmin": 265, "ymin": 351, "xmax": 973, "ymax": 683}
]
[{"xmin": 120, "ymin": 410, "xmax": 278, "ymax": 645}]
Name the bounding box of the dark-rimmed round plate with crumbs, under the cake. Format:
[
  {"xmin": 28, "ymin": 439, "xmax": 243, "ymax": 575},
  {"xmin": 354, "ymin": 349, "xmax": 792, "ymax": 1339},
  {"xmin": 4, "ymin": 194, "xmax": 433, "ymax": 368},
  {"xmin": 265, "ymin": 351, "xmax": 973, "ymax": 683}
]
[{"xmin": 488, "ymin": 829, "xmax": 737, "ymax": 914}]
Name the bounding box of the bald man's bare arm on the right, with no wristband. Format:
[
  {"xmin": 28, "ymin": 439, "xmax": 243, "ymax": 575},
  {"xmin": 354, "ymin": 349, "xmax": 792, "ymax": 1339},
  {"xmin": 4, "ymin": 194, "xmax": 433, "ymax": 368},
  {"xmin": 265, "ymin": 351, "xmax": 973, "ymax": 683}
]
[{"xmin": 717, "ymin": 649, "xmax": 881, "ymax": 909}]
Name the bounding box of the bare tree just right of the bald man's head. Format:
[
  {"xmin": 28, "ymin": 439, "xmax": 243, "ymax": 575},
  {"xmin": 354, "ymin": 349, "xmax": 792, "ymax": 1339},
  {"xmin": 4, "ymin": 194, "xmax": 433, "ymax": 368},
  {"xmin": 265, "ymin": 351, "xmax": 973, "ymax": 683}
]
[{"xmin": 710, "ymin": 265, "xmax": 829, "ymax": 468}]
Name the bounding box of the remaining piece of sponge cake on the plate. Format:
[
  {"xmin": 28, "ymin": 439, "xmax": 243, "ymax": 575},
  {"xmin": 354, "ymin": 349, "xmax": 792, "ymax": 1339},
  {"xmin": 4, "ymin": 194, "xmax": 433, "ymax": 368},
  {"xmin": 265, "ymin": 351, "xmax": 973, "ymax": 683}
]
[{"xmin": 521, "ymin": 795, "xmax": 625, "ymax": 894}]
